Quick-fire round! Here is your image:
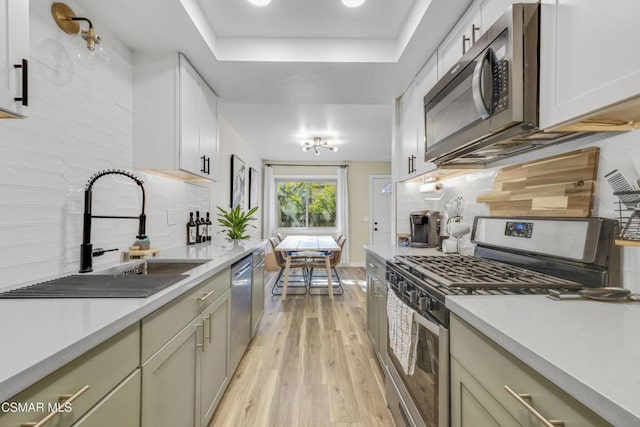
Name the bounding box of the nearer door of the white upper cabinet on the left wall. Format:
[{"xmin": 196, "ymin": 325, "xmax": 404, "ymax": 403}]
[{"xmin": 180, "ymin": 56, "xmax": 204, "ymax": 175}]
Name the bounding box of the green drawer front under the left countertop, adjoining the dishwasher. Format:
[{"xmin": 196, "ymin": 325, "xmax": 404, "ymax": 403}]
[{"xmin": 142, "ymin": 268, "xmax": 231, "ymax": 362}]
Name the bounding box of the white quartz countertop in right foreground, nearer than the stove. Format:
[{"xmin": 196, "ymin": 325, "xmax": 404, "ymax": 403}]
[{"xmin": 446, "ymin": 295, "xmax": 640, "ymax": 426}]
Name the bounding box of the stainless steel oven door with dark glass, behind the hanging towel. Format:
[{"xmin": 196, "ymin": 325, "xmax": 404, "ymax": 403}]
[{"xmin": 387, "ymin": 288, "xmax": 449, "ymax": 427}]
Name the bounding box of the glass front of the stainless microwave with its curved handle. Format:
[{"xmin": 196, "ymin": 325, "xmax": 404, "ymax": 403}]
[{"xmin": 424, "ymin": 30, "xmax": 515, "ymax": 162}]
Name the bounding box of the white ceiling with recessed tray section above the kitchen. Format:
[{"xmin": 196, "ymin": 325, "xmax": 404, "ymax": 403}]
[{"xmin": 81, "ymin": 0, "xmax": 471, "ymax": 161}]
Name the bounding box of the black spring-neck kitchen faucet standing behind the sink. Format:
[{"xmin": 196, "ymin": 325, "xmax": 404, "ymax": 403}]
[{"xmin": 80, "ymin": 169, "xmax": 147, "ymax": 273}]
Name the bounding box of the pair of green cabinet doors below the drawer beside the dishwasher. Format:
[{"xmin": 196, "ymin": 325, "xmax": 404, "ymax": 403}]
[{"xmin": 142, "ymin": 290, "xmax": 231, "ymax": 427}]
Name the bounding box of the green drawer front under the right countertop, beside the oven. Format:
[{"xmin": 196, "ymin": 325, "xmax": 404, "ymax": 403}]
[{"xmin": 451, "ymin": 315, "xmax": 611, "ymax": 427}]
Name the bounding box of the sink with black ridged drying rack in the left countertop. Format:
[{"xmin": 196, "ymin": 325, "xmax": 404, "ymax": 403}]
[{"xmin": 0, "ymin": 260, "xmax": 210, "ymax": 299}]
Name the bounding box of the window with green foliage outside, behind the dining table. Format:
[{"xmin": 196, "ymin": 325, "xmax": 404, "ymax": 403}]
[{"xmin": 276, "ymin": 179, "xmax": 337, "ymax": 228}]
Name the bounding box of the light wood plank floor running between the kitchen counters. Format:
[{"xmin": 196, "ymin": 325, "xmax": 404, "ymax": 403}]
[{"xmin": 209, "ymin": 268, "xmax": 393, "ymax": 427}]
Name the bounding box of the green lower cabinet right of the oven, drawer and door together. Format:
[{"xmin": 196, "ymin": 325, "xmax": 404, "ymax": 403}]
[{"xmin": 450, "ymin": 315, "xmax": 611, "ymax": 427}]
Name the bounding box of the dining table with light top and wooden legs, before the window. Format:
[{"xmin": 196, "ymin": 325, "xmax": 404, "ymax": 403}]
[{"xmin": 275, "ymin": 236, "xmax": 341, "ymax": 301}]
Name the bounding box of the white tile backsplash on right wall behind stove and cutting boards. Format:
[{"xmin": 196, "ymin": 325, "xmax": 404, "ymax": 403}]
[{"xmin": 397, "ymin": 131, "xmax": 640, "ymax": 292}]
